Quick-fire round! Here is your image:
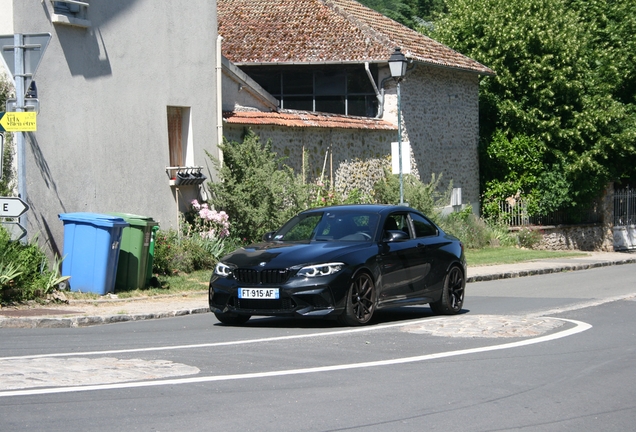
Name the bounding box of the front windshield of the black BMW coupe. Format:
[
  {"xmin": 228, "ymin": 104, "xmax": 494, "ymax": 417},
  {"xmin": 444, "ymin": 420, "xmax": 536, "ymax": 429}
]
[{"xmin": 274, "ymin": 211, "xmax": 379, "ymax": 242}]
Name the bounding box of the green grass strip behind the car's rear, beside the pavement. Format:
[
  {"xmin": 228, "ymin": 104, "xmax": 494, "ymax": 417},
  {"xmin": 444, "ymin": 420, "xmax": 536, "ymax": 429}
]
[{"xmin": 466, "ymin": 247, "xmax": 587, "ymax": 266}]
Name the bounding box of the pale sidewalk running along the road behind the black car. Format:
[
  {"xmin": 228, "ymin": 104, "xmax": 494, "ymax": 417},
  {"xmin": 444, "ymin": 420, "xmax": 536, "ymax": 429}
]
[{"xmin": 0, "ymin": 252, "xmax": 636, "ymax": 328}]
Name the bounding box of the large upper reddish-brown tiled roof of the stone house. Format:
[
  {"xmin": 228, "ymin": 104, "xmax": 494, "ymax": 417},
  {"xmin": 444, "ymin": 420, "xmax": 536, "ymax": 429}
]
[{"xmin": 217, "ymin": 0, "xmax": 494, "ymax": 75}]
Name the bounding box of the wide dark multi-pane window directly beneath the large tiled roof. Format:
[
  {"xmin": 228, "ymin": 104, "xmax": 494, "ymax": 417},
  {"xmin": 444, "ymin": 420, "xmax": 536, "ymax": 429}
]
[{"xmin": 242, "ymin": 65, "xmax": 378, "ymax": 117}]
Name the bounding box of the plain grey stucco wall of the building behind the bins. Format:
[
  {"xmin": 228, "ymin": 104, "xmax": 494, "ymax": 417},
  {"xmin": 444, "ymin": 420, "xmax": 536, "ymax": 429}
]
[{"xmin": 0, "ymin": 0, "xmax": 218, "ymax": 254}]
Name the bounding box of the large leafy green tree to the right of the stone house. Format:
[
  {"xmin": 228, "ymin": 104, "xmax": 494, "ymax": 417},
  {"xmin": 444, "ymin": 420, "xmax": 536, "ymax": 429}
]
[{"xmin": 429, "ymin": 0, "xmax": 636, "ymax": 215}]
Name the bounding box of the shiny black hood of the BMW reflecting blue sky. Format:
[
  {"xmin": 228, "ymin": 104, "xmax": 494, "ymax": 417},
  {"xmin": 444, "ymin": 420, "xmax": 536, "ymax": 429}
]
[{"xmin": 221, "ymin": 241, "xmax": 377, "ymax": 268}]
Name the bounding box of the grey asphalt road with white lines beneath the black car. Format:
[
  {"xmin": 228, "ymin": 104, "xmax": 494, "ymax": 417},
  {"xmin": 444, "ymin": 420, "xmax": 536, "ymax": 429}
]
[{"xmin": 0, "ymin": 264, "xmax": 636, "ymax": 431}]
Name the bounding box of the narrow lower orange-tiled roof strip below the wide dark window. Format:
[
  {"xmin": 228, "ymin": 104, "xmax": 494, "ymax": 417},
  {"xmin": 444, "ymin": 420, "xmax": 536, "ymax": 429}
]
[{"xmin": 223, "ymin": 110, "xmax": 397, "ymax": 130}]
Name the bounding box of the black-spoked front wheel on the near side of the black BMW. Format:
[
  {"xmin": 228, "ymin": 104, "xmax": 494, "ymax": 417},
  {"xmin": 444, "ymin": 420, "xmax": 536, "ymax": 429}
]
[{"xmin": 338, "ymin": 272, "xmax": 376, "ymax": 326}]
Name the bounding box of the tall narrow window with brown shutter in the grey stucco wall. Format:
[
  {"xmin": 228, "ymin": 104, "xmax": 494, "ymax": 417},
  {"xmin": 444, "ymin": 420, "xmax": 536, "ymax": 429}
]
[{"xmin": 168, "ymin": 106, "xmax": 194, "ymax": 178}]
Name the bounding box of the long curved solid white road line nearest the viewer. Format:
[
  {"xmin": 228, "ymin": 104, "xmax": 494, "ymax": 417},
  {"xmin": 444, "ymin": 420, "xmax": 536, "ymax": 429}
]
[{"xmin": 0, "ymin": 318, "xmax": 592, "ymax": 397}]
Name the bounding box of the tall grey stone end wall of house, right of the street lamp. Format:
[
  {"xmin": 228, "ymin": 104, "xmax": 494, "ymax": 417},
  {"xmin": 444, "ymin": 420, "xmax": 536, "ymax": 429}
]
[{"xmin": 398, "ymin": 65, "xmax": 480, "ymax": 214}]
